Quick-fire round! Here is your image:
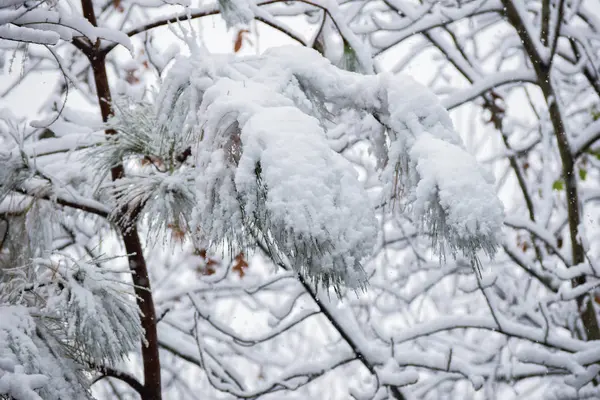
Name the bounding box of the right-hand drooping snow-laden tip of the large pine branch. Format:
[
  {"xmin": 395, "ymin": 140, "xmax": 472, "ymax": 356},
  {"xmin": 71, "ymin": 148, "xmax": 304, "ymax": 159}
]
[{"xmin": 384, "ymin": 76, "xmax": 503, "ymax": 265}]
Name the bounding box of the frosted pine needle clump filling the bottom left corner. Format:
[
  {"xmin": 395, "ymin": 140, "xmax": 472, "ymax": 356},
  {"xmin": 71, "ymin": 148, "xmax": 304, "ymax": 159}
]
[{"xmin": 0, "ymin": 254, "xmax": 142, "ymax": 400}]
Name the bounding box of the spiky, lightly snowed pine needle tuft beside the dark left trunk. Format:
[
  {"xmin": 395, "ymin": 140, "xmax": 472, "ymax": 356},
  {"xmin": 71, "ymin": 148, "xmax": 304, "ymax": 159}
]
[{"xmin": 98, "ymin": 104, "xmax": 195, "ymax": 240}]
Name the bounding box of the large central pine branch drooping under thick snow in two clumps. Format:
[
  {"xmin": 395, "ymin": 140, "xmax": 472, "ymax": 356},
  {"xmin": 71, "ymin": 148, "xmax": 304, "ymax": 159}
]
[{"xmin": 108, "ymin": 47, "xmax": 503, "ymax": 290}]
